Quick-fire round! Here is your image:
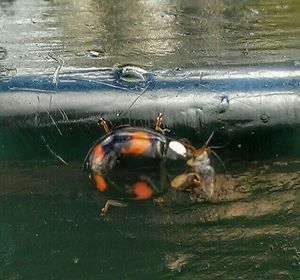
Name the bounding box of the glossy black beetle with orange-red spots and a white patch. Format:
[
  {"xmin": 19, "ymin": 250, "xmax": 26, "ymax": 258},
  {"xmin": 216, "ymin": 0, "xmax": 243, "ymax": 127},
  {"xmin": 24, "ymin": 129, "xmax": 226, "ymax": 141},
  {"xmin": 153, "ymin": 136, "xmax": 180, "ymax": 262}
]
[{"xmin": 83, "ymin": 113, "xmax": 215, "ymax": 213}]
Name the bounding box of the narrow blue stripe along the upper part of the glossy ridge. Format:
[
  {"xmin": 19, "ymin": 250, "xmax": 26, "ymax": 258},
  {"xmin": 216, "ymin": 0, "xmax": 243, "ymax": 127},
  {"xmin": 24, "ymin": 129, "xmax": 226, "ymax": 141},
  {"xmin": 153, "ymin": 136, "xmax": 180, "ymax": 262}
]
[{"xmin": 0, "ymin": 65, "xmax": 300, "ymax": 93}]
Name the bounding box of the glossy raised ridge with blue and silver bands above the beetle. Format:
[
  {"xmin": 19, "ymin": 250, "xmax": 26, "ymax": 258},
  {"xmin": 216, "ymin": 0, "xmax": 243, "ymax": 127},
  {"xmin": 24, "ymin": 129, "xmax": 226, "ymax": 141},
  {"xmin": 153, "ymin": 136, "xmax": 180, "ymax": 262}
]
[{"xmin": 0, "ymin": 65, "xmax": 300, "ymax": 135}]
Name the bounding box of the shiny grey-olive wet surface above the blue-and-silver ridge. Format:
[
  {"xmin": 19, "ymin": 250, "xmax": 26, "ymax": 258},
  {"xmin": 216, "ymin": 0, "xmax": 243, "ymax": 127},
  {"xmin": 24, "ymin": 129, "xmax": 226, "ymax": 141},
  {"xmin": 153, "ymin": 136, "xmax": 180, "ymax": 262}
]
[{"xmin": 0, "ymin": 0, "xmax": 300, "ymax": 73}]
